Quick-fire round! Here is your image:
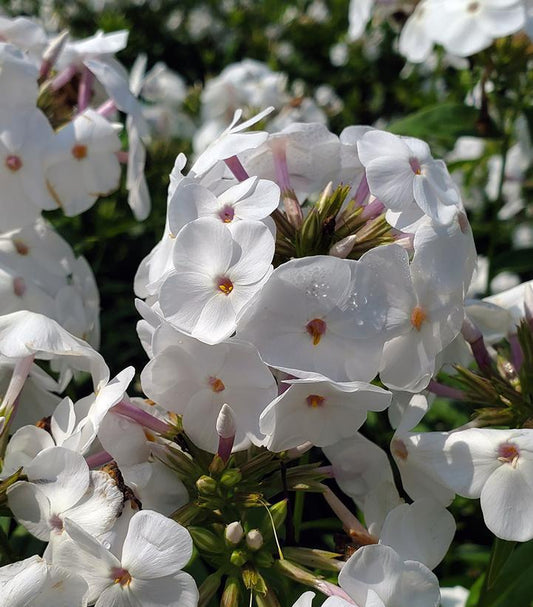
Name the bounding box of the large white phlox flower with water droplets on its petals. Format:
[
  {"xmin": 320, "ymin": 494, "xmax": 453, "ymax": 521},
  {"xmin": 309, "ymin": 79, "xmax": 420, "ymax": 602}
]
[{"xmin": 237, "ymin": 251, "xmax": 404, "ymax": 382}]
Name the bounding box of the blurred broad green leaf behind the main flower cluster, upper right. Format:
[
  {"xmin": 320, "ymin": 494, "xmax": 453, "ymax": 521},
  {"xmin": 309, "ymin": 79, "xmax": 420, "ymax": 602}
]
[{"xmin": 387, "ymin": 103, "xmax": 498, "ymax": 148}]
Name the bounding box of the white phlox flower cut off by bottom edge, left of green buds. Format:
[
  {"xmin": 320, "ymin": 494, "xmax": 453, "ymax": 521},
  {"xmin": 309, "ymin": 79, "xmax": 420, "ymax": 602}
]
[{"xmin": 54, "ymin": 510, "xmax": 198, "ymax": 607}]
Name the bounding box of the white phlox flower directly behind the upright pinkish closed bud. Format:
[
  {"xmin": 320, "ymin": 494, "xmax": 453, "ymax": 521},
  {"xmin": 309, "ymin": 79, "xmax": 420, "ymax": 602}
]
[{"xmin": 141, "ymin": 326, "xmax": 277, "ymax": 453}]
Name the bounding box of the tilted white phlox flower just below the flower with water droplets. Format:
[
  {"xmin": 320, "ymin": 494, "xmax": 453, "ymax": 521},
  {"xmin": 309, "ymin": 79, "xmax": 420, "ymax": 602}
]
[{"xmin": 259, "ymin": 379, "xmax": 392, "ymax": 451}]
